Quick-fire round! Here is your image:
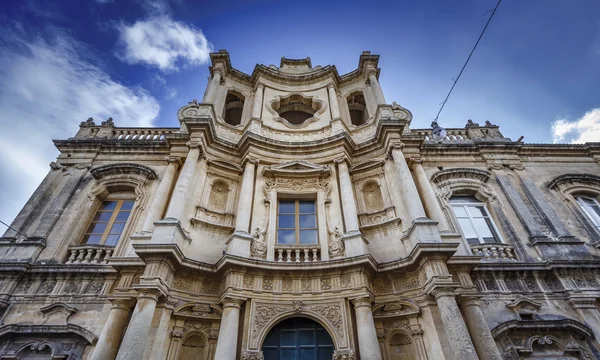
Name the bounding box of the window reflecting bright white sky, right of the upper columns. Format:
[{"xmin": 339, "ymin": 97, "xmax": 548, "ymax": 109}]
[{"xmin": 450, "ymin": 196, "xmax": 502, "ymax": 245}]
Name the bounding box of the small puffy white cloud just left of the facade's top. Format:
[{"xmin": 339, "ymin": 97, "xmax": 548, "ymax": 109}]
[{"xmin": 117, "ymin": 14, "xmax": 213, "ymax": 71}]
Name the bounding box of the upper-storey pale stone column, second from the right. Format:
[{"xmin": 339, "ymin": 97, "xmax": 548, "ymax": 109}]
[{"xmin": 391, "ymin": 144, "xmax": 427, "ymax": 224}]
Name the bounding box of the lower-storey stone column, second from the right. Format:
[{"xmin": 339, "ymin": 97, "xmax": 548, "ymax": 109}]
[{"xmin": 431, "ymin": 288, "xmax": 479, "ymax": 360}]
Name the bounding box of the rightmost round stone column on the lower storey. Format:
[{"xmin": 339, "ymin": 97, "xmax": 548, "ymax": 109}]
[{"xmin": 461, "ymin": 298, "xmax": 502, "ymax": 360}]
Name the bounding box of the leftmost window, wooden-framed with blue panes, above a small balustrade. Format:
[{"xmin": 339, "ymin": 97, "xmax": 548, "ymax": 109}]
[{"xmin": 82, "ymin": 200, "xmax": 134, "ymax": 246}]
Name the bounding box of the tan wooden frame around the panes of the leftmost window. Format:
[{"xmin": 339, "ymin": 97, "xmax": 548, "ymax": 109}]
[{"xmin": 79, "ymin": 192, "xmax": 137, "ymax": 248}]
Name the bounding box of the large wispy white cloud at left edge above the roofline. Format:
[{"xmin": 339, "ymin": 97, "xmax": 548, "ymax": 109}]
[{"xmin": 0, "ymin": 29, "xmax": 160, "ymax": 228}]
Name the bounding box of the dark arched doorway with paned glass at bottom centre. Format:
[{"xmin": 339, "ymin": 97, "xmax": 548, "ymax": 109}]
[{"xmin": 262, "ymin": 317, "xmax": 334, "ymax": 360}]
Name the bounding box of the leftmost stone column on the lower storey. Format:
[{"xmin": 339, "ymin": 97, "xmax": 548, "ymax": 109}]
[{"xmin": 90, "ymin": 299, "xmax": 133, "ymax": 360}]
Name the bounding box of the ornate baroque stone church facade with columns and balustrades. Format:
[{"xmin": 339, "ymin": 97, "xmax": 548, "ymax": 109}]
[{"xmin": 0, "ymin": 50, "xmax": 600, "ymax": 360}]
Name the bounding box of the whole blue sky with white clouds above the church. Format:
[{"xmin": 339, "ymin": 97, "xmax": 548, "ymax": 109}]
[{"xmin": 0, "ymin": 0, "xmax": 600, "ymax": 228}]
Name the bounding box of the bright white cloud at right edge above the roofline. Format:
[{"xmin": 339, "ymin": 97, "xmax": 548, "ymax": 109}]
[{"xmin": 552, "ymin": 108, "xmax": 600, "ymax": 143}]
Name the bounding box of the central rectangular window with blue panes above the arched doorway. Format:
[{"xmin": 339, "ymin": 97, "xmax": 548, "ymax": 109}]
[{"xmin": 277, "ymin": 200, "xmax": 318, "ymax": 245}]
